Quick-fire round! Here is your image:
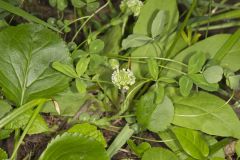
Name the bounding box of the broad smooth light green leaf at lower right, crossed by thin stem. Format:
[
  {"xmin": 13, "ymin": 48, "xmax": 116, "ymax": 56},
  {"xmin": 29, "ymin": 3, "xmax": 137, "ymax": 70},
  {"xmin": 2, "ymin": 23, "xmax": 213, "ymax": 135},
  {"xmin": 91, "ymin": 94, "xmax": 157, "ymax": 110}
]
[{"xmin": 172, "ymin": 92, "xmax": 240, "ymax": 139}]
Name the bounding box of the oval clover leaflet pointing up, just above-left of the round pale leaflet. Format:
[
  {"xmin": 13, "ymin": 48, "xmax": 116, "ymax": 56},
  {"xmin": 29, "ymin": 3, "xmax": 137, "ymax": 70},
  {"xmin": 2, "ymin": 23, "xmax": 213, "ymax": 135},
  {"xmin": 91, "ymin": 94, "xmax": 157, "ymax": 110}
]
[{"xmin": 188, "ymin": 52, "xmax": 206, "ymax": 74}]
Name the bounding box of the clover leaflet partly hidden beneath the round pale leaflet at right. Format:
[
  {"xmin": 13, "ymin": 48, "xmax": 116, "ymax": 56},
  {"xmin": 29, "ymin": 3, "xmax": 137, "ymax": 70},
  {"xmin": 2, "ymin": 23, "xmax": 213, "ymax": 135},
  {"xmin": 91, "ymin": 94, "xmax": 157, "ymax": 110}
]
[{"xmin": 188, "ymin": 74, "xmax": 219, "ymax": 92}]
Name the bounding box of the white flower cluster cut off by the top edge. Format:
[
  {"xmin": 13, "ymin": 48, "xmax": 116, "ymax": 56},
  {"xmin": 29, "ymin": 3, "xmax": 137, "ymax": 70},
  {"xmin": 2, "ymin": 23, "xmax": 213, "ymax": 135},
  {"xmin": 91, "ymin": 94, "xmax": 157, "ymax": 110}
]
[{"xmin": 120, "ymin": 0, "xmax": 143, "ymax": 17}]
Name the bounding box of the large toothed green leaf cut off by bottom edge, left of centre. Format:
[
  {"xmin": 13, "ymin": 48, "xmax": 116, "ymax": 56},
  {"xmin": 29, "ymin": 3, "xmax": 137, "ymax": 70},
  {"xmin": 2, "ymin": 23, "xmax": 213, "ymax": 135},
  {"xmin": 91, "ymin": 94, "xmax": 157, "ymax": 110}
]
[{"xmin": 39, "ymin": 133, "xmax": 109, "ymax": 160}]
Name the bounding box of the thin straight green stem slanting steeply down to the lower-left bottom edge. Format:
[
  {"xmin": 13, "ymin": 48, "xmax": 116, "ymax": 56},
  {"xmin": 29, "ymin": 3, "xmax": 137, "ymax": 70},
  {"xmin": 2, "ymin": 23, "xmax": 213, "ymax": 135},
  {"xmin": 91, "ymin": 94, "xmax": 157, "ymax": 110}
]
[{"xmin": 10, "ymin": 101, "xmax": 45, "ymax": 160}]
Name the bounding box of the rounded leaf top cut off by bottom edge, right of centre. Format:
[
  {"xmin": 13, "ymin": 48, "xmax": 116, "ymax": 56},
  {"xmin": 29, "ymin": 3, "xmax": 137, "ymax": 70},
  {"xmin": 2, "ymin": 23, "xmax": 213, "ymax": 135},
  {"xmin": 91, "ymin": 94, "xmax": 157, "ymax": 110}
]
[{"xmin": 142, "ymin": 147, "xmax": 178, "ymax": 160}]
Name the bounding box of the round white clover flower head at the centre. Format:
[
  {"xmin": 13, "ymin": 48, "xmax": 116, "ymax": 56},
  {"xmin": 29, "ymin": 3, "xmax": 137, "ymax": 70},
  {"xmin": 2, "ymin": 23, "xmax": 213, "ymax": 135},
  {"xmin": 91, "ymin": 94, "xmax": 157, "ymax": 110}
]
[{"xmin": 112, "ymin": 68, "xmax": 136, "ymax": 90}]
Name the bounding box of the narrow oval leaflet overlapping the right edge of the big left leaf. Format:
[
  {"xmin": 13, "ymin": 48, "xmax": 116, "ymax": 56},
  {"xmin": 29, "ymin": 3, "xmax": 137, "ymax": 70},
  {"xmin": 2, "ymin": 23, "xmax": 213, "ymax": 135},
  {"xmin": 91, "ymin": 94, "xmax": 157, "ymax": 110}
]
[{"xmin": 52, "ymin": 62, "xmax": 78, "ymax": 78}]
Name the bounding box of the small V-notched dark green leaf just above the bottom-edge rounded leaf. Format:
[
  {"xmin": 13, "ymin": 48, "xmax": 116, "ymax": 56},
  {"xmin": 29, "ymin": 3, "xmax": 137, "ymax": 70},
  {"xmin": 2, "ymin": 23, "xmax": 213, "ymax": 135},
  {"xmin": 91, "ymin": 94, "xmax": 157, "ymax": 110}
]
[{"xmin": 127, "ymin": 139, "xmax": 151, "ymax": 157}]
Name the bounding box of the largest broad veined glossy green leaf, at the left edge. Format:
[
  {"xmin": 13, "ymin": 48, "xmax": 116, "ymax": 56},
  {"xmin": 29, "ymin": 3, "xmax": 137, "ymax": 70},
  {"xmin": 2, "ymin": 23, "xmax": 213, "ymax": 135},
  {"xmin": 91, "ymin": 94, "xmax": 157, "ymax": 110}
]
[{"xmin": 0, "ymin": 24, "xmax": 71, "ymax": 106}]
